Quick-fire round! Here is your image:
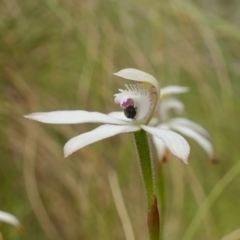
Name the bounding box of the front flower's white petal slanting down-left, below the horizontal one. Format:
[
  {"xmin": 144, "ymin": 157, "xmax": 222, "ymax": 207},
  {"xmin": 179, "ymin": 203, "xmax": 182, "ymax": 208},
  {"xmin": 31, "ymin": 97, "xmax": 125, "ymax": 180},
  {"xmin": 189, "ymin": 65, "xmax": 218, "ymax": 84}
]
[{"xmin": 64, "ymin": 124, "xmax": 140, "ymax": 157}]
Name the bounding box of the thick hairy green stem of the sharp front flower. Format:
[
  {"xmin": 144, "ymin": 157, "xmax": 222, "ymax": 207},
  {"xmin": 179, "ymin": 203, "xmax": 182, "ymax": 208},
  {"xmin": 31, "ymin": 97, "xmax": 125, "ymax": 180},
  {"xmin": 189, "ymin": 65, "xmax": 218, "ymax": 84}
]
[{"xmin": 134, "ymin": 130, "xmax": 160, "ymax": 240}]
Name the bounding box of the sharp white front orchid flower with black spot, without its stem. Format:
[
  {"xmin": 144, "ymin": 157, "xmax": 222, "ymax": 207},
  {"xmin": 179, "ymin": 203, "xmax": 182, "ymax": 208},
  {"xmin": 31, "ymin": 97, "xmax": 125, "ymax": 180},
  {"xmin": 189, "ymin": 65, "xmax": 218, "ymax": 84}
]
[{"xmin": 25, "ymin": 68, "xmax": 190, "ymax": 163}]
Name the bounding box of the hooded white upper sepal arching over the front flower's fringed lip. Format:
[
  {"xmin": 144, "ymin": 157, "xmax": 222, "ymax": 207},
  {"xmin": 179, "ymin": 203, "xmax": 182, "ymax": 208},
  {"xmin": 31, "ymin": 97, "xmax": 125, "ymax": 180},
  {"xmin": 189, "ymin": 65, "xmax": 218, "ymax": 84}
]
[{"xmin": 114, "ymin": 68, "xmax": 159, "ymax": 91}]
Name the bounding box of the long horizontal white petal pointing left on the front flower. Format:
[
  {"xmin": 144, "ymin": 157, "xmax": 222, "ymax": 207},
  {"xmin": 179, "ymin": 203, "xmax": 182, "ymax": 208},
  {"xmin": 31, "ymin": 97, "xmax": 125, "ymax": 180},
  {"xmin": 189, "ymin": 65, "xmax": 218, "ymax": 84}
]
[{"xmin": 24, "ymin": 110, "xmax": 127, "ymax": 124}]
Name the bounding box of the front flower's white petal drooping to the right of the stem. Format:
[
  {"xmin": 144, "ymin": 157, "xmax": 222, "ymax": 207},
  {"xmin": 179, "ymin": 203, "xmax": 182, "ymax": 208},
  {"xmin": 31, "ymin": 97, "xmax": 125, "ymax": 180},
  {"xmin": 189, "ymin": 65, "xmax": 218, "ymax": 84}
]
[{"xmin": 141, "ymin": 125, "xmax": 190, "ymax": 163}]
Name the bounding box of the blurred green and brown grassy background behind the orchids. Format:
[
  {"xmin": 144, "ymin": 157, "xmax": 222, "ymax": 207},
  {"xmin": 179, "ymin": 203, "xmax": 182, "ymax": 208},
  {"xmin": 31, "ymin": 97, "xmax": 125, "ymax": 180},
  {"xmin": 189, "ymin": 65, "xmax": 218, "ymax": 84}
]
[{"xmin": 0, "ymin": 0, "xmax": 240, "ymax": 240}]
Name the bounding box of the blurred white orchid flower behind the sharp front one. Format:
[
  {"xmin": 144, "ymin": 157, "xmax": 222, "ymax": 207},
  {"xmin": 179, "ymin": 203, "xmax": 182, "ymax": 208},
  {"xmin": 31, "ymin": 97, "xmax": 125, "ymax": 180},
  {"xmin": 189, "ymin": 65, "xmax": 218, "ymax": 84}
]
[{"xmin": 151, "ymin": 86, "xmax": 215, "ymax": 161}]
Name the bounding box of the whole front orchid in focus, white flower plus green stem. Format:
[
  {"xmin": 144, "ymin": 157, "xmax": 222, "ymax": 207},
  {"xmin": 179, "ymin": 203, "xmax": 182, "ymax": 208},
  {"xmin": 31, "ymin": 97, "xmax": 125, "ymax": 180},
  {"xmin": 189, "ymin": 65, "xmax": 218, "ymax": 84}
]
[{"xmin": 25, "ymin": 68, "xmax": 190, "ymax": 240}]
